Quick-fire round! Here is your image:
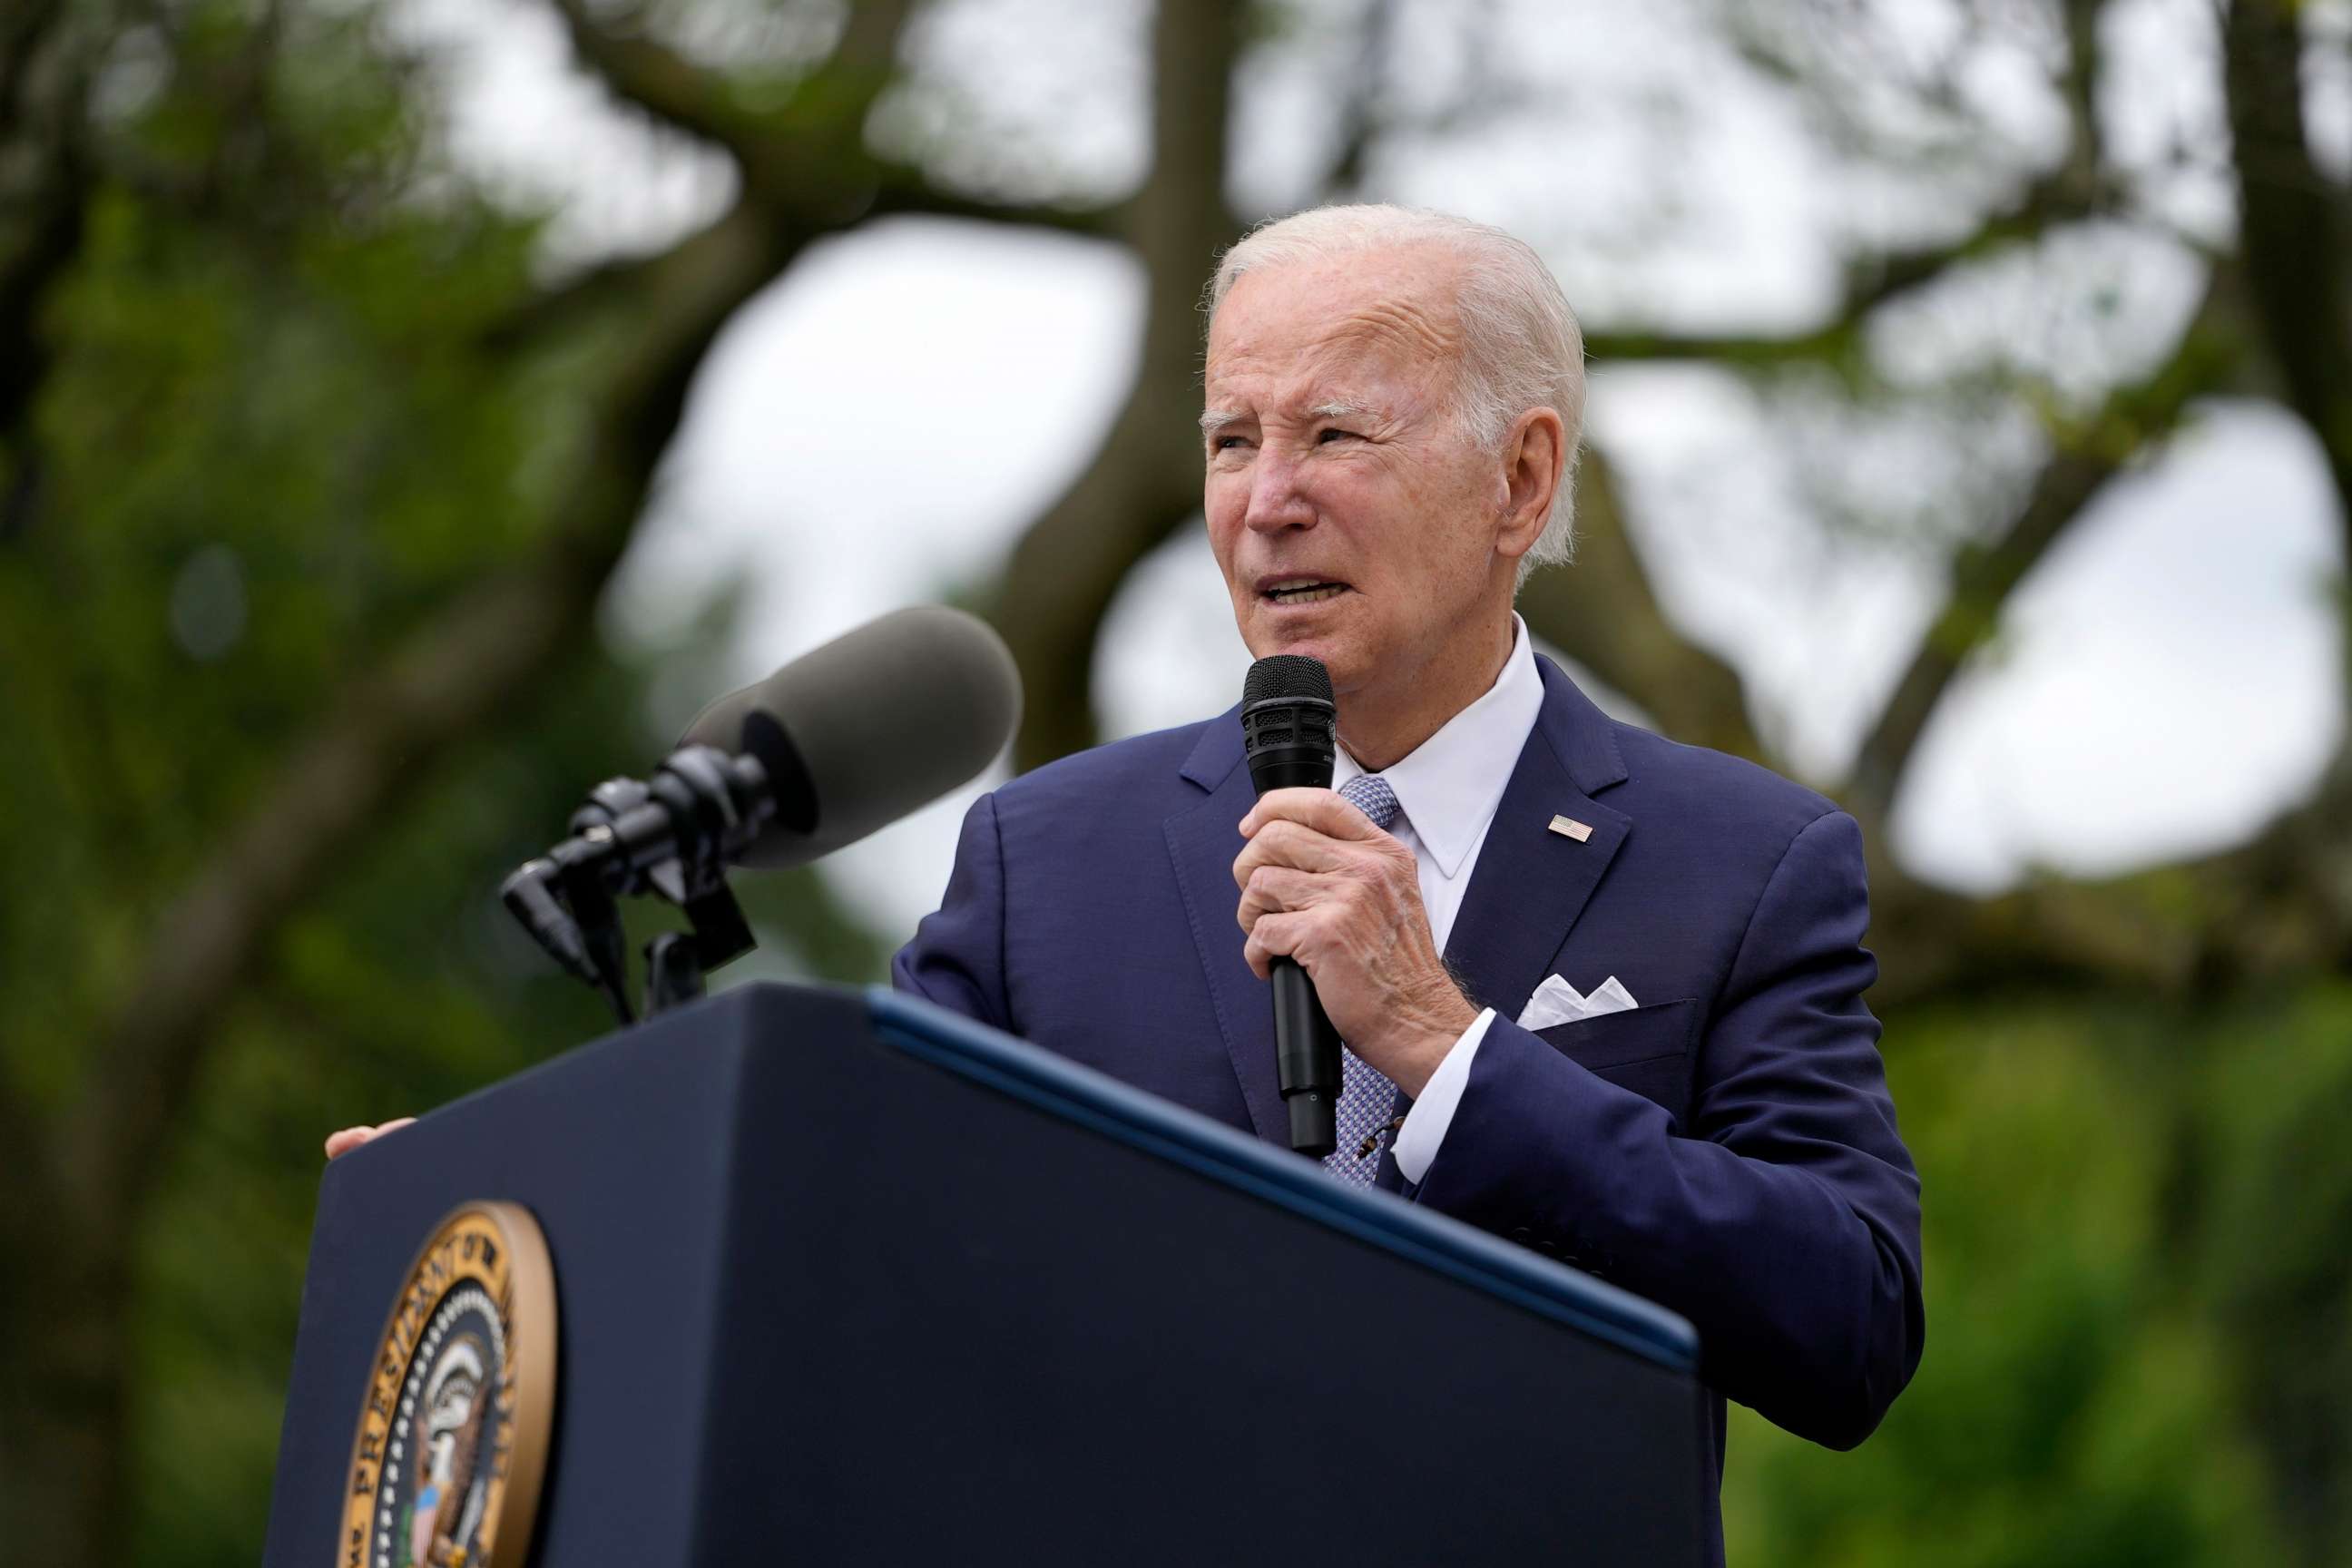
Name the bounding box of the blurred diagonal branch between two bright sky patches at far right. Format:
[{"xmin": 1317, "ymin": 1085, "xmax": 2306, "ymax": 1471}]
[{"xmin": 1842, "ymin": 296, "xmax": 2237, "ymax": 823}]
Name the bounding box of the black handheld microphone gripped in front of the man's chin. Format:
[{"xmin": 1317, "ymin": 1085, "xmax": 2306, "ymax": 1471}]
[{"xmin": 1242, "ymin": 653, "xmax": 1340, "ymax": 1159}]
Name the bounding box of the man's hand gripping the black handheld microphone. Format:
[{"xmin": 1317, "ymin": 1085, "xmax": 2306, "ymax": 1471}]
[{"xmin": 1232, "ymin": 789, "xmax": 1477, "ymax": 1095}]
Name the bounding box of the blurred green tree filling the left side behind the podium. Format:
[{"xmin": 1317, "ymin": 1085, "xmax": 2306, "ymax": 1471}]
[{"xmin": 0, "ymin": 0, "xmax": 983, "ymax": 1563}]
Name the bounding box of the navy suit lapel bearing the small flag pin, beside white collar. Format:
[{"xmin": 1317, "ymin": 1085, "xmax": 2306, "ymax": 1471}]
[{"xmin": 1446, "ymin": 658, "xmax": 1632, "ymax": 1018}]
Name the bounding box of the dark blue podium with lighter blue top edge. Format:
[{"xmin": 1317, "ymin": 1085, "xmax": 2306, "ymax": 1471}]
[{"xmin": 266, "ymin": 985, "xmax": 1712, "ymax": 1568}]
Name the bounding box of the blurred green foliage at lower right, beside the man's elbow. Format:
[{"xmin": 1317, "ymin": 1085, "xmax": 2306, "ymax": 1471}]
[{"xmin": 1724, "ymin": 983, "xmax": 2352, "ymax": 1568}]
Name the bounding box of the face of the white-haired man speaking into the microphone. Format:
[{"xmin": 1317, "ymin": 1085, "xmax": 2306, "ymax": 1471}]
[{"xmin": 1202, "ymin": 247, "xmax": 1513, "ymax": 693}]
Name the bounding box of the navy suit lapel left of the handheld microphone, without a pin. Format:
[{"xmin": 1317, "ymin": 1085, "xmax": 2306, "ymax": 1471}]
[{"xmin": 1164, "ymin": 715, "xmax": 1291, "ymax": 1145}]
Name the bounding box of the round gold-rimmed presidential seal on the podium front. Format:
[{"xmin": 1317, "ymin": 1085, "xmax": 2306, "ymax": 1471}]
[{"xmin": 334, "ymin": 1203, "xmax": 555, "ymax": 1568}]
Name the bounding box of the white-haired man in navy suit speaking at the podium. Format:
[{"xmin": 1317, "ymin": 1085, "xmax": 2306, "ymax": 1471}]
[{"xmin": 894, "ymin": 207, "xmax": 1924, "ymax": 1553}]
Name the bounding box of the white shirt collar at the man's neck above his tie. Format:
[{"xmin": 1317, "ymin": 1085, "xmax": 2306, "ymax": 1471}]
[{"xmin": 1331, "ymin": 613, "xmax": 1543, "ymax": 882}]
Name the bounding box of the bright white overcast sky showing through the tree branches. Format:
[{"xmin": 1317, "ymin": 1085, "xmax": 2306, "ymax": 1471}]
[{"xmin": 399, "ymin": 0, "xmax": 2352, "ymax": 938}]
